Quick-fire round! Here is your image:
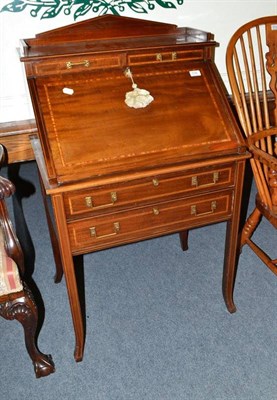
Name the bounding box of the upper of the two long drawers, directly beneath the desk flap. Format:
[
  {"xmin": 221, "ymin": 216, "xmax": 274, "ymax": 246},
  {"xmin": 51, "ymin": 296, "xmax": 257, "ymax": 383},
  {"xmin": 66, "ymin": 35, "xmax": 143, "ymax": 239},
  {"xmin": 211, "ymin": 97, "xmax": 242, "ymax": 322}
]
[{"xmin": 64, "ymin": 165, "xmax": 234, "ymax": 218}]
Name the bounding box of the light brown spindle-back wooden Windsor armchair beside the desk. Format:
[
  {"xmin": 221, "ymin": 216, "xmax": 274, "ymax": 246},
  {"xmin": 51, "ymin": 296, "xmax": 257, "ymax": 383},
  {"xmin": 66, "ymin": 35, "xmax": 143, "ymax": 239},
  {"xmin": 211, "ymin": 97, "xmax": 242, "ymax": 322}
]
[{"xmin": 226, "ymin": 15, "xmax": 277, "ymax": 275}]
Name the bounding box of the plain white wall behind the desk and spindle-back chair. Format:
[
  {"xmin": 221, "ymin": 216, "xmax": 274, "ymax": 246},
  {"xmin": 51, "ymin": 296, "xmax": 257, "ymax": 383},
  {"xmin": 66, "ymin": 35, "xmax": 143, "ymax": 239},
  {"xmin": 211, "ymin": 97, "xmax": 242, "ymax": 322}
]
[{"xmin": 0, "ymin": 0, "xmax": 277, "ymax": 123}]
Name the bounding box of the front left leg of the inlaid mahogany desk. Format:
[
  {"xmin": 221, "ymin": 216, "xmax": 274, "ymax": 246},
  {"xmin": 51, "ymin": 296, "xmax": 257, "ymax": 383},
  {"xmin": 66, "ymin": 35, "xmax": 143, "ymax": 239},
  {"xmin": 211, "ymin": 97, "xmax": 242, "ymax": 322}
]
[{"xmin": 51, "ymin": 194, "xmax": 85, "ymax": 361}]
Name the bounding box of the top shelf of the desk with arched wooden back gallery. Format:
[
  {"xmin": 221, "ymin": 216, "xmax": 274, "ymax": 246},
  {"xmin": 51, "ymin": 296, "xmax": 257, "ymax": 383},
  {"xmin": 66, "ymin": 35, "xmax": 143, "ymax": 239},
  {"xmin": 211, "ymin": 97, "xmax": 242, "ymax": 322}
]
[{"xmin": 21, "ymin": 15, "xmax": 217, "ymax": 61}]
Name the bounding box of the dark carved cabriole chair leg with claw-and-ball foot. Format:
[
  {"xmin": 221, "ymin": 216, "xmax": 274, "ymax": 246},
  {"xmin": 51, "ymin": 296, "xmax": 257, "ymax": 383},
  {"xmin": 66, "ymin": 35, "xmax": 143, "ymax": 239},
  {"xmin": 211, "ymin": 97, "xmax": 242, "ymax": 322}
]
[{"xmin": 0, "ymin": 285, "xmax": 55, "ymax": 378}]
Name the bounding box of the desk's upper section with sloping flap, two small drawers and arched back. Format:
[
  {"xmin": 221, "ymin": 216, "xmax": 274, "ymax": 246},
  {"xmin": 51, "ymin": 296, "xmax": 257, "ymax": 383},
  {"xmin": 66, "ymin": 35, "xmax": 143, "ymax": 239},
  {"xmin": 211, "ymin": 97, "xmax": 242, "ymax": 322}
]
[{"xmin": 22, "ymin": 16, "xmax": 244, "ymax": 183}]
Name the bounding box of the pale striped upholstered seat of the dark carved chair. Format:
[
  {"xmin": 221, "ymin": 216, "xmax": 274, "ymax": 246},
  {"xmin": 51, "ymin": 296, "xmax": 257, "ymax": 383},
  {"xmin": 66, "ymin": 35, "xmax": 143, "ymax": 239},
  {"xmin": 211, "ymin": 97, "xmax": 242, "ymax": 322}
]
[{"xmin": 0, "ymin": 229, "xmax": 23, "ymax": 296}]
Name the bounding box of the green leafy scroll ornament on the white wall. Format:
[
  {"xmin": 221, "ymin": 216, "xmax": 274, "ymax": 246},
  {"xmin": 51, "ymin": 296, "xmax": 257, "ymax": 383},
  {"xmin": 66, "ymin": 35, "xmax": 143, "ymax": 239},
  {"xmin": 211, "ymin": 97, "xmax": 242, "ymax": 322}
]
[{"xmin": 0, "ymin": 0, "xmax": 184, "ymax": 20}]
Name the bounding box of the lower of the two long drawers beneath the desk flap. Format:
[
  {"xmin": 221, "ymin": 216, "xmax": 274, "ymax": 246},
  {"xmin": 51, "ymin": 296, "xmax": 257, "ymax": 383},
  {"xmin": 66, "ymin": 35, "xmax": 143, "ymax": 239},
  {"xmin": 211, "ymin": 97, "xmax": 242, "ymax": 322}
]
[{"xmin": 68, "ymin": 191, "xmax": 232, "ymax": 254}]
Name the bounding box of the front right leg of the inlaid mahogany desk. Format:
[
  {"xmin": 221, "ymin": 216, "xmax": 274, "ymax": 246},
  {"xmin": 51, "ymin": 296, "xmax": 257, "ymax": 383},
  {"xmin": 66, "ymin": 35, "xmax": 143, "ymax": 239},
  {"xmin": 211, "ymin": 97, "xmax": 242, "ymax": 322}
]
[{"xmin": 222, "ymin": 161, "xmax": 245, "ymax": 313}]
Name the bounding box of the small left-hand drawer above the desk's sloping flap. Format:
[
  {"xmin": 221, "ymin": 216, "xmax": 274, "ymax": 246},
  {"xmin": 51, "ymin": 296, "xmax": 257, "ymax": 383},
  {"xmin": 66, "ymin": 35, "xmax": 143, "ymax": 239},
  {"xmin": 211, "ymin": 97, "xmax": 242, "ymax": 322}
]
[{"xmin": 33, "ymin": 55, "xmax": 121, "ymax": 75}]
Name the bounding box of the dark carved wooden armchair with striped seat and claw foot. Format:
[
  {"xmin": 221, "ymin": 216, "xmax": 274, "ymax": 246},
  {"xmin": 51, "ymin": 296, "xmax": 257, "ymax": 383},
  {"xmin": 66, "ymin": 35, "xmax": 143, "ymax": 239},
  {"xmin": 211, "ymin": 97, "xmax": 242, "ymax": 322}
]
[{"xmin": 0, "ymin": 145, "xmax": 55, "ymax": 378}]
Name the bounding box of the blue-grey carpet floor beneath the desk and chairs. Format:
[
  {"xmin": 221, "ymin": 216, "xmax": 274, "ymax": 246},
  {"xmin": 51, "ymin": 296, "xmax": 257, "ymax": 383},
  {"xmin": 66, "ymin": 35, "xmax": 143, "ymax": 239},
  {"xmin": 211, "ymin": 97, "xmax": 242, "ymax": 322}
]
[{"xmin": 0, "ymin": 163, "xmax": 277, "ymax": 400}]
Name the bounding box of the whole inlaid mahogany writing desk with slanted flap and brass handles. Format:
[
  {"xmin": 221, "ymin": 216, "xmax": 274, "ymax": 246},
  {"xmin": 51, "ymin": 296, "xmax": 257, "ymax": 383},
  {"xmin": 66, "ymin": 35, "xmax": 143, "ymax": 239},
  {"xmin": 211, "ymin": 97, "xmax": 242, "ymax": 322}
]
[{"xmin": 21, "ymin": 15, "xmax": 247, "ymax": 361}]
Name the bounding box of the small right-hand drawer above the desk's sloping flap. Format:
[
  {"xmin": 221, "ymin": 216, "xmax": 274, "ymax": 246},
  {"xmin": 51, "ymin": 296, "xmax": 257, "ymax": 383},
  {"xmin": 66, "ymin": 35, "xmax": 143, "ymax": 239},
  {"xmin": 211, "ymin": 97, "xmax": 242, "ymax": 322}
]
[{"xmin": 128, "ymin": 49, "xmax": 203, "ymax": 66}]
